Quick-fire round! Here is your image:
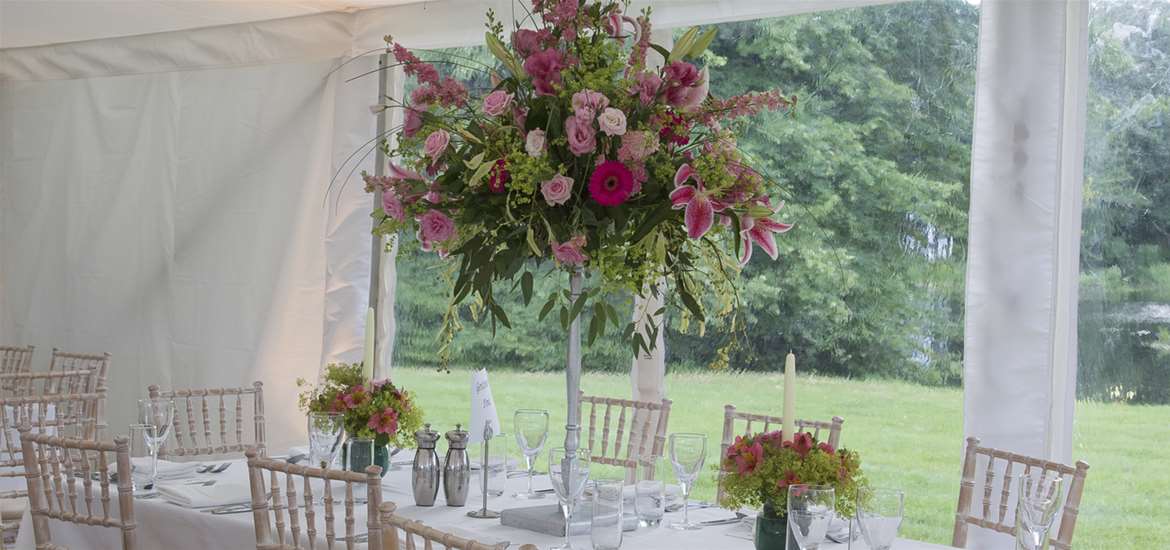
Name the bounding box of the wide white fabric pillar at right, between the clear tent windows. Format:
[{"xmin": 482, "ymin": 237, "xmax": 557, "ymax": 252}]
[{"xmin": 963, "ymin": 0, "xmax": 1088, "ymax": 503}]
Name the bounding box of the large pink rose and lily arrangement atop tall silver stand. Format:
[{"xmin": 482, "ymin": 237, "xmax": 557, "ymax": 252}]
[{"xmin": 364, "ymin": 0, "xmax": 796, "ymax": 360}]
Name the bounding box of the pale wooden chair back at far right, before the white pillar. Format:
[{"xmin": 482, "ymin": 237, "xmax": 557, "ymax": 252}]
[{"xmin": 951, "ymin": 438, "xmax": 1089, "ymax": 550}]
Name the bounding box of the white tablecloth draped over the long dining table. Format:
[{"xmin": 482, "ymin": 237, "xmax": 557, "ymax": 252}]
[{"xmin": 14, "ymin": 455, "xmax": 949, "ymax": 550}]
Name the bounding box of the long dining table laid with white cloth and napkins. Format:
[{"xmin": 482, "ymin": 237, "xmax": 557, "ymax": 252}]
[{"xmin": 5, "ymin": 451, "xmax": 950, "ymax": 550}]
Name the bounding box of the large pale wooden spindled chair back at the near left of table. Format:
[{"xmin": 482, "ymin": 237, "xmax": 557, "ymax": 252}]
[{"xmin": 20, "ymin": 425, "xmax": 137, "ymax": 550}]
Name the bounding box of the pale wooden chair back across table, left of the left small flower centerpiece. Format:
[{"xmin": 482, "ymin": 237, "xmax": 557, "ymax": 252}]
[{"xmin": 147, "ymin": 381, "xmax": 264, "ymax": 456}]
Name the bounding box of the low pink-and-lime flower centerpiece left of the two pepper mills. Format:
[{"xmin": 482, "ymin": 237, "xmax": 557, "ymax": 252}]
[{"xmin": 297, "ymin": 363, "xmax": 422, "ymax": 474}]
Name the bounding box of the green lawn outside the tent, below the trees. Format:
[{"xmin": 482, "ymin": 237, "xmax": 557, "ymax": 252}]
[{"xmin": 394, "ymin": 369, "xmax": 1170, "ymax": 549}]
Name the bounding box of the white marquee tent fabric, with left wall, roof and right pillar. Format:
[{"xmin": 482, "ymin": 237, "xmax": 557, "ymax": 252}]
[{"xmin": 0, "ymin": 0, "xmax": 1087, "ymax": 524}]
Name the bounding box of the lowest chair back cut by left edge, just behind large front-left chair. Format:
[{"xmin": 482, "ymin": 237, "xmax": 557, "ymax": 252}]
[{"xmin": 0, "ymin": 389, "xmax": 105, "ymax": 477}]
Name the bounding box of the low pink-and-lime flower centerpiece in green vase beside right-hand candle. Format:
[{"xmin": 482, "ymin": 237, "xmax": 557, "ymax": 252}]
[{"xmin": 720, "ymin": 431, "xmax": 867, "ymax": 550}]
